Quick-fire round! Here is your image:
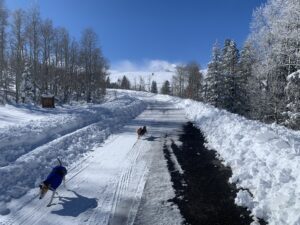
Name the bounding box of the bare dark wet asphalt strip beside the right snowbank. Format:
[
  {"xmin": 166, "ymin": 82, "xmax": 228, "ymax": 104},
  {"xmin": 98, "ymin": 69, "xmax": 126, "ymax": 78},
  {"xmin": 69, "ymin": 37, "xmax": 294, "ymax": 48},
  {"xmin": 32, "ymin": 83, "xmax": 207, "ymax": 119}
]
[{"xmin": 163, "ymin": 123, "xmax": 266, "ymax": 225}]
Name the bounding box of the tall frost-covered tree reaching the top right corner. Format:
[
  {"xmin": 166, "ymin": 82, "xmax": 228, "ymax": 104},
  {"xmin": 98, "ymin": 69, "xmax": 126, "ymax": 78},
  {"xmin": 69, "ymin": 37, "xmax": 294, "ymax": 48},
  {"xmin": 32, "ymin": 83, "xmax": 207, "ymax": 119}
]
[{"xmin": 250, "ymin": 0, "xmax": 300, "ymax": 123}]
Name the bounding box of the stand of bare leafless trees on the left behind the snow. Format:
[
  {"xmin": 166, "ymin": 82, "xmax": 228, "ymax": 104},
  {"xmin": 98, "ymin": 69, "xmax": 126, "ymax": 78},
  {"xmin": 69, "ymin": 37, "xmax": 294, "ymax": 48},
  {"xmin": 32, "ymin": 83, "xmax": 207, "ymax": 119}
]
[{"xmin": 0, "ymin": 0, "xmax": 108, "ymax": 104}]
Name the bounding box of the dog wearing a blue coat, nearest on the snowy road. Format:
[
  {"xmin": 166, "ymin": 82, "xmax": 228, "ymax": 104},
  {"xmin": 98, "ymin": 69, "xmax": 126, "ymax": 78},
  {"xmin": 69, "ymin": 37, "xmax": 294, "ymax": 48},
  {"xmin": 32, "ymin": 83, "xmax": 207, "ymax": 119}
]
[{"xmin": 39, "ymin": 159, "xmax": 67, "ymax": 207}]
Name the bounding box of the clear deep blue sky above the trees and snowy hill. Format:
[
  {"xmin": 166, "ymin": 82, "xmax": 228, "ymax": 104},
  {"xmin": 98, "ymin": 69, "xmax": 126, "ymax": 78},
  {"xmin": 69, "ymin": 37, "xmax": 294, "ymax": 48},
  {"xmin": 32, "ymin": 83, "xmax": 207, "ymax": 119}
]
[{"xmin": 6, "ymin": 0, "xmax": 266, "ymax": 68}]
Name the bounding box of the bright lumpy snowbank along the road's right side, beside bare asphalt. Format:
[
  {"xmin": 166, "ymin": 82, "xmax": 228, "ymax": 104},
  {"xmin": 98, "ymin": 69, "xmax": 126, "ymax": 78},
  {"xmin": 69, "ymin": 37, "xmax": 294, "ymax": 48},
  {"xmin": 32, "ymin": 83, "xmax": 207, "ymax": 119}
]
[{"xmin": 176, "ymin": 99, "xmax": 300, "ymax": 225}]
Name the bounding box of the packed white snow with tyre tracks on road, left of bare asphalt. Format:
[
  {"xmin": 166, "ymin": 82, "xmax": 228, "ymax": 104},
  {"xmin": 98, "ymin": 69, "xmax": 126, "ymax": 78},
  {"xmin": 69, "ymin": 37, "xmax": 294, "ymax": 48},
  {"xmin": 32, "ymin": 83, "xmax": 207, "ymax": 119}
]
[{"xmin": 0, "ymin": 101, "xmax": 186, "ymax": 225}]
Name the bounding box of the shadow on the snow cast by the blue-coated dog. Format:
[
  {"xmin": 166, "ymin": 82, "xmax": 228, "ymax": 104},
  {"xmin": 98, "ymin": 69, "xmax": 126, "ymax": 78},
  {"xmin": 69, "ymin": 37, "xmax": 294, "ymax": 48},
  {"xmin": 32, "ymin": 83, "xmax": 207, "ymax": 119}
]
[{"xmin": 51, "ymin": 190, "xmax": 98, "ymax": 217}]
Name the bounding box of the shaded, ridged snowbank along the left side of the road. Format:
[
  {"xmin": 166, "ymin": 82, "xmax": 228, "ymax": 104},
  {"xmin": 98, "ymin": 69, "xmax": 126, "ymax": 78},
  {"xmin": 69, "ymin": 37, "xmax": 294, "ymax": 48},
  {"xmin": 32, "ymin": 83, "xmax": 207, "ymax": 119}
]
[{"xmin": 0, "ymin": 95, "xmax": 146, "ymax": 214}]
